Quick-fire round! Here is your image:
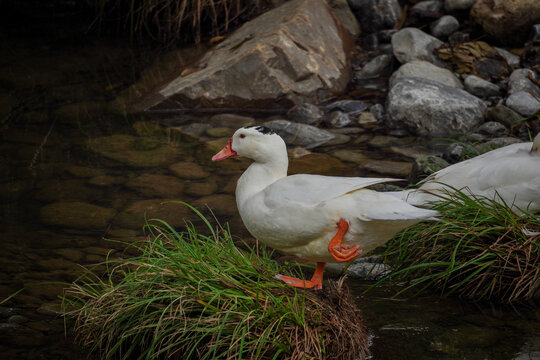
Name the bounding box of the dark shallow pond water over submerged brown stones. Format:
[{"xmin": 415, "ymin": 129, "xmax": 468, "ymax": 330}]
[{"xmin": 0, "ymin": 9, "xmax": 540, "ymax": 360}]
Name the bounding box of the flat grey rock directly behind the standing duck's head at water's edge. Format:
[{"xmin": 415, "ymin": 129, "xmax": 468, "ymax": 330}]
[{"xmin": 264, "ymin": 120, "xmax": 337, "ymax": 149}]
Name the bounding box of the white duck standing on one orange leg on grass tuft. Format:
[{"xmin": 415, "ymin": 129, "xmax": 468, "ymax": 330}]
[{"xmin": 212, "ymin": 126, "xmax": 438, "ymax": 289}]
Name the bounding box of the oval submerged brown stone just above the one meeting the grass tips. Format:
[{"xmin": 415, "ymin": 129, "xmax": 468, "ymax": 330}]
[{"xmin": 126, "ymin": 174, "xmax": 184, "ymax": 198}]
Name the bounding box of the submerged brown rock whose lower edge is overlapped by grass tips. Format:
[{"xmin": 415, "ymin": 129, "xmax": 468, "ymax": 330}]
[{"xmin": 114, "ymin": 199, "xmax": 197, "ymax": 229}]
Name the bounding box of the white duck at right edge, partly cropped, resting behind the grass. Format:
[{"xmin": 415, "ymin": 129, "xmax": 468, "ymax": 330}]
[{"xmin": 392, "ymin": 134, "xmax": 540, "ymax": 212}]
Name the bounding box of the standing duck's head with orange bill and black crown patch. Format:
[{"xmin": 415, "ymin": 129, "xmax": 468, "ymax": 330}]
[{"xmin": 212, "ymin": 125, "xmax": 287, "ymax": 162}]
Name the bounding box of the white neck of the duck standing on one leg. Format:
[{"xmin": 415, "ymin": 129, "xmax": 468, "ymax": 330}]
[{"xmin": 236, "ymin": 153, "xmax": 289, "ymax": 207}]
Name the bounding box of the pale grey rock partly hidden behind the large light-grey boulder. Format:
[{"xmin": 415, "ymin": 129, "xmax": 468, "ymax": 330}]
[{"xmin": 389, "ymin": 60, "xmax": 463, "ymax": 89}]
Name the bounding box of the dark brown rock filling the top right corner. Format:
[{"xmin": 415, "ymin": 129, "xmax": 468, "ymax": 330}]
[{"xmin": 470, "ymin": 0, "xmax": 540, "ymax": 45}]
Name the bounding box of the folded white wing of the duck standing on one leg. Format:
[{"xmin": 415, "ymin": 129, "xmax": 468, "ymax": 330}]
[{"xmin": 263, "ymin": 174, "xmax": 401, "ymax": 208}]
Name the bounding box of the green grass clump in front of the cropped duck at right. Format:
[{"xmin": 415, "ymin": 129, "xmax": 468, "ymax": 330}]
[{"xmin": 381, "ymin": 191, "xmax": 540, "ymax": 302}]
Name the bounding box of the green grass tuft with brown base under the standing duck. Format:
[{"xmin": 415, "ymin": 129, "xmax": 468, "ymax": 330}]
[{"xmin": 65, "ymin": 205, "xmax": 368, "ymax": 359}]
